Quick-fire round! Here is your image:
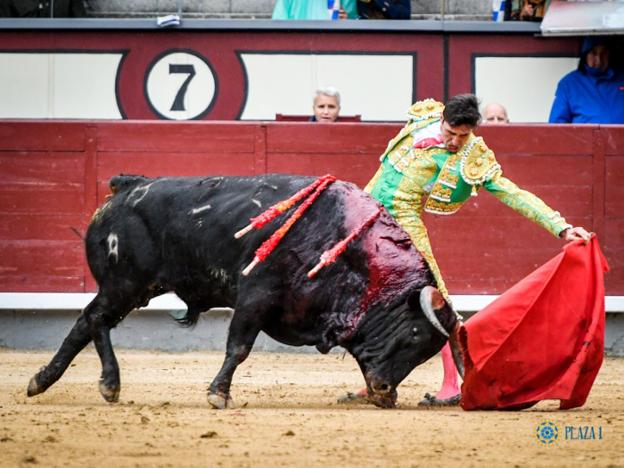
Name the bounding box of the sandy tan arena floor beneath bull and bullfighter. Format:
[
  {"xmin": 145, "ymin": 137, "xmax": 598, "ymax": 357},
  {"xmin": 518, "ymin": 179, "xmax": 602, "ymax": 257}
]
[{"xmin": 0, "ymin": 349, "xmax": 624, "ymax": 467}]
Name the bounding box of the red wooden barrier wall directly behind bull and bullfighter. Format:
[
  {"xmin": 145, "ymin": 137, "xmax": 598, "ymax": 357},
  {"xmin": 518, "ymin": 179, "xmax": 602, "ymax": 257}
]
[{"xmin": 0, "ymin": 121, "xmax": 624, "ymax": 295}]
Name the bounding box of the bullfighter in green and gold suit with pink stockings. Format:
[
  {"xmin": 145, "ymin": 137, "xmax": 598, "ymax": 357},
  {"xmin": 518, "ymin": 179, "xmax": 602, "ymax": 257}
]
[{"xmin": 341, "ymin": 94, "xmax": 590, "ymax": 405}]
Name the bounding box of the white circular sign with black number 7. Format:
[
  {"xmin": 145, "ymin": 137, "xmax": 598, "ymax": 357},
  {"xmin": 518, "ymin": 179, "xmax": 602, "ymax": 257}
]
[{"xmin": 145, "ymin": 51, "xmax": 217, "ymax": 120}]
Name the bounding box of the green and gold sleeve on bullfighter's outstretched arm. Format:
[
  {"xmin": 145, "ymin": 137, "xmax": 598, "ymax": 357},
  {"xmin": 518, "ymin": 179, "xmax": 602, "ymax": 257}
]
[{"xmin": 483, "ymin": 171, "xmax": 572, "ymax": 237}]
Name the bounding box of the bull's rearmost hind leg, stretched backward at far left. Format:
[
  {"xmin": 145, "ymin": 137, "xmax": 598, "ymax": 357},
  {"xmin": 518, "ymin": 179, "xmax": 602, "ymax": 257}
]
[{"xmin": 26, "ymin": 312, "xmax": 91, "ymax": 396}]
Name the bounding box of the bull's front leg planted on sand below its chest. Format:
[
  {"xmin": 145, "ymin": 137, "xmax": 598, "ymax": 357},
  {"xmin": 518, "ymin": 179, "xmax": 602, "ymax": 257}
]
[{"xmin": 208, "ymin": 308, "xmax": 260, "ymax": 409}]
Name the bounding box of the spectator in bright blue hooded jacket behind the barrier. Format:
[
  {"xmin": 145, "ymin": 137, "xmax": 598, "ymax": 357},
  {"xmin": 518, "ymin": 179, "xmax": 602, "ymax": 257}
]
[{"xmin": 548, "ymin": 36, "xmax": 624, "ymax": 124}]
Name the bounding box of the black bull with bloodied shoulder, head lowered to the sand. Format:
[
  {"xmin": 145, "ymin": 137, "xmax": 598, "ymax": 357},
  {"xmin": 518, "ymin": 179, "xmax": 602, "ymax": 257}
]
[{"xmin": 28, "ymin": 175, "xmax": 456, "ymax": 408}]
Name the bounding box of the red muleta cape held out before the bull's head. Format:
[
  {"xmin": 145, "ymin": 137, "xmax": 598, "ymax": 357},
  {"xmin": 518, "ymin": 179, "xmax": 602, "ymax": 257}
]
[{"xmin": 460, "ymin": 236, "xmax": 609, "ymax": 410}]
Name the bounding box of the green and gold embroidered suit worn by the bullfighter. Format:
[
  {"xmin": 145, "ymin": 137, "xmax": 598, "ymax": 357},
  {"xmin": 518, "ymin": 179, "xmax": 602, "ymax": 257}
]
[{"xmin": 365, "ymin": 99, "xmax": 571, "ymax": 299}]
